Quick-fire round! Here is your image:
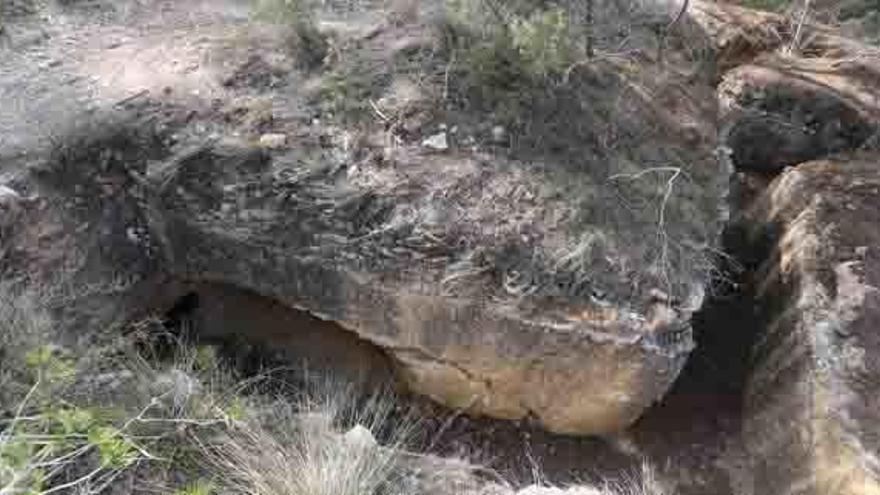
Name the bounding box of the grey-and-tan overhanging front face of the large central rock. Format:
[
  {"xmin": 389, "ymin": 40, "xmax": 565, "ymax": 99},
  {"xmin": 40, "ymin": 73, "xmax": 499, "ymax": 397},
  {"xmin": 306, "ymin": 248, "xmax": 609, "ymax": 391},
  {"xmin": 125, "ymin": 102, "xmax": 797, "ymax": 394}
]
[{"xmin": 143, "ymin": 138, "xmax": 708, "ymax": 433}]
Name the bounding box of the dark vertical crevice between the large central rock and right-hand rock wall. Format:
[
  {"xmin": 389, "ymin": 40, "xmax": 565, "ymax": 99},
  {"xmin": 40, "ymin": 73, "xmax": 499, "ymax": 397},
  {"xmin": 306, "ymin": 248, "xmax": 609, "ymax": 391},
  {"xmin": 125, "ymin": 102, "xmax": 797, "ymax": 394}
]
[{"xmin": 620, "ymin": 172, "xmax": 776, "ymax": 495}]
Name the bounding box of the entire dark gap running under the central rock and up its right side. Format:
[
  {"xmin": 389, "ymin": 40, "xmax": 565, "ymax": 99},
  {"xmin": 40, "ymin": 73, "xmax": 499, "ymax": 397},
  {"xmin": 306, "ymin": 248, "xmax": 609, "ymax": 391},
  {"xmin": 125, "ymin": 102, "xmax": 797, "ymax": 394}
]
[{"xmin": 148, "ymin": 237, "xmax": 763, "ymax": 495}]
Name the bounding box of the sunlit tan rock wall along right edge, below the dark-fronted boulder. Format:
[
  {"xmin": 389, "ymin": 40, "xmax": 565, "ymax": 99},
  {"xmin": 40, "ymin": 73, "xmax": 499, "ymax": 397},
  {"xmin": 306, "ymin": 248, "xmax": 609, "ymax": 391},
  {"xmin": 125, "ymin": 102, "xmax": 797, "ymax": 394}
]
[{"xmin": 746, "ymin": 154, "xmax": 880, "ymax": 495}]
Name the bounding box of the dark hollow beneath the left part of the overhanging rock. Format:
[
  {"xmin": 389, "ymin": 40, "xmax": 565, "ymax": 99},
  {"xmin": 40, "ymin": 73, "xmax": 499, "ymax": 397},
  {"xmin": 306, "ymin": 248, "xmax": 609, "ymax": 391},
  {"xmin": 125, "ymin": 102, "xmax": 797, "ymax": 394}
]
[{"xmin": 156, "ymin": 283, "xmax": 395, "ymax": 387}]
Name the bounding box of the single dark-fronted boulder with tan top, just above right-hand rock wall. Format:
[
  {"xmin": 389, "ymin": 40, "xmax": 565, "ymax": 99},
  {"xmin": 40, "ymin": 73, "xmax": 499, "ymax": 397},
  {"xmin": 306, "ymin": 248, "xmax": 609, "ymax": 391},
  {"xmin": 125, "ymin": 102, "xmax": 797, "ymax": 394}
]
[{"xmin": 718, "ymin": 47, "xmax": 880, "ymax": 172}]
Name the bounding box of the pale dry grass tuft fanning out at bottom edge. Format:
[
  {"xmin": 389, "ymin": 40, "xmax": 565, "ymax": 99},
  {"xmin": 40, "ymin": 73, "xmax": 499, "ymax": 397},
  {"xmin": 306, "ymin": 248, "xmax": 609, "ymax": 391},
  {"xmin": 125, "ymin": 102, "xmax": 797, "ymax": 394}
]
[{"xmin": 198, "ymin": 388, "xmax": 422, "ymax": 495}]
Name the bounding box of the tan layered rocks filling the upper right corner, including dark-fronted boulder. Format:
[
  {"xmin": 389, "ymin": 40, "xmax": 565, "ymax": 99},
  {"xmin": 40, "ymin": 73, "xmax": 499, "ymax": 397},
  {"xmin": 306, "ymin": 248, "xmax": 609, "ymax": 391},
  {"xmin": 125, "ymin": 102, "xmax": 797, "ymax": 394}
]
[{"xmin": 689, "ymin": 0, "xmax": 880, "ymax": 174}]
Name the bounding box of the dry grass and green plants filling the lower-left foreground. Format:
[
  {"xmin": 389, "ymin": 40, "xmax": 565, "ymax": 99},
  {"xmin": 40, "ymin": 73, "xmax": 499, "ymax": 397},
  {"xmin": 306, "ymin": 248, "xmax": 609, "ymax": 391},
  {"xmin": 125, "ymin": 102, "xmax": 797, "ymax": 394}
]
[{"xmin": 0, "ymin": 283, "xmax": 662, "ymax": 495}]
